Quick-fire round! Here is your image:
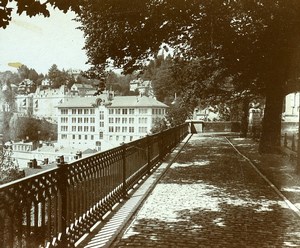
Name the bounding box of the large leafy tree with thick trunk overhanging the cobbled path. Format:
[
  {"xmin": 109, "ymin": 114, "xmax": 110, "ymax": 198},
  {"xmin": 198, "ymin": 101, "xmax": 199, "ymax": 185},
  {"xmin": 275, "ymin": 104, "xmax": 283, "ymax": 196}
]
[{"xmin": 78, "ymin": 0, "xmax": 300, "ymax": 152}]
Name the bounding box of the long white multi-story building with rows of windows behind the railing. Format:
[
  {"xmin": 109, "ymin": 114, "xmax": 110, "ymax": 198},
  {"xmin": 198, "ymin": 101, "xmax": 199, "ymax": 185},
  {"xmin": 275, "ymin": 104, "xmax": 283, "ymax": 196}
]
[{"xmin": 58, "ymin": 93, "xmax": 168, "ymax": 151}]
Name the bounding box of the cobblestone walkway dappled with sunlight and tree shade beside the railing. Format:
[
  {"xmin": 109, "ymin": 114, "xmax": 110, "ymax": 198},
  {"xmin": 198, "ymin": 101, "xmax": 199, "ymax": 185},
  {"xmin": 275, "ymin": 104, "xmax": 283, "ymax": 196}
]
[{"xmin": 110, "ymin": 135, "xmax": 300, "ymax": 248}]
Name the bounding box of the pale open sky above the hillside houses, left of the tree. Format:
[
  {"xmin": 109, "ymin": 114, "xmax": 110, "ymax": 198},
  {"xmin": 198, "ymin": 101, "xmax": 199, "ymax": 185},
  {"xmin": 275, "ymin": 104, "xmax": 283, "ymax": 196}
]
[{"xmin": 0, "ymin": 6, "xmax": 89, "ymax": 74}]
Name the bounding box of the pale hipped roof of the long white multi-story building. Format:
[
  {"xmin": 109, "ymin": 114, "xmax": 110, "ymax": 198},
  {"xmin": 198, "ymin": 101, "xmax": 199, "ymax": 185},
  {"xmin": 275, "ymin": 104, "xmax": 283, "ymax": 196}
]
[{"xmin": 58, "ymin": 94, "xmax": 168, "ymax": 108}]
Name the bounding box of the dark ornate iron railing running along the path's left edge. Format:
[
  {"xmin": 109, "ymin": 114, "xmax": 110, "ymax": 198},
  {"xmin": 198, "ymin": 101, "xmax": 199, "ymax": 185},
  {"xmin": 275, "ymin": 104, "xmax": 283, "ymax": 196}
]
[{"xmin": 0, "ymin": 124, "xmax": 188, "ymax": 248}]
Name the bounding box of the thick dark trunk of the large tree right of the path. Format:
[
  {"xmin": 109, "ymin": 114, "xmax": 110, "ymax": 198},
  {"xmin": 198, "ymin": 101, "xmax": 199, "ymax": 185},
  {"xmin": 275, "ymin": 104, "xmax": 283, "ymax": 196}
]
[{"xmin": 259, "ymin": 85, "xmax": 284, "ymax": 154}]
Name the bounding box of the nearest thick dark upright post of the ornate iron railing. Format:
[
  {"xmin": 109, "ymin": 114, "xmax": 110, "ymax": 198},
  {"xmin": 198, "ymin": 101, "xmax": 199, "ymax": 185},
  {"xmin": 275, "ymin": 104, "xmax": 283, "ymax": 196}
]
[{"xmin": 57, "ymin": 156, "xmax": 69, "ymax": 248}]
